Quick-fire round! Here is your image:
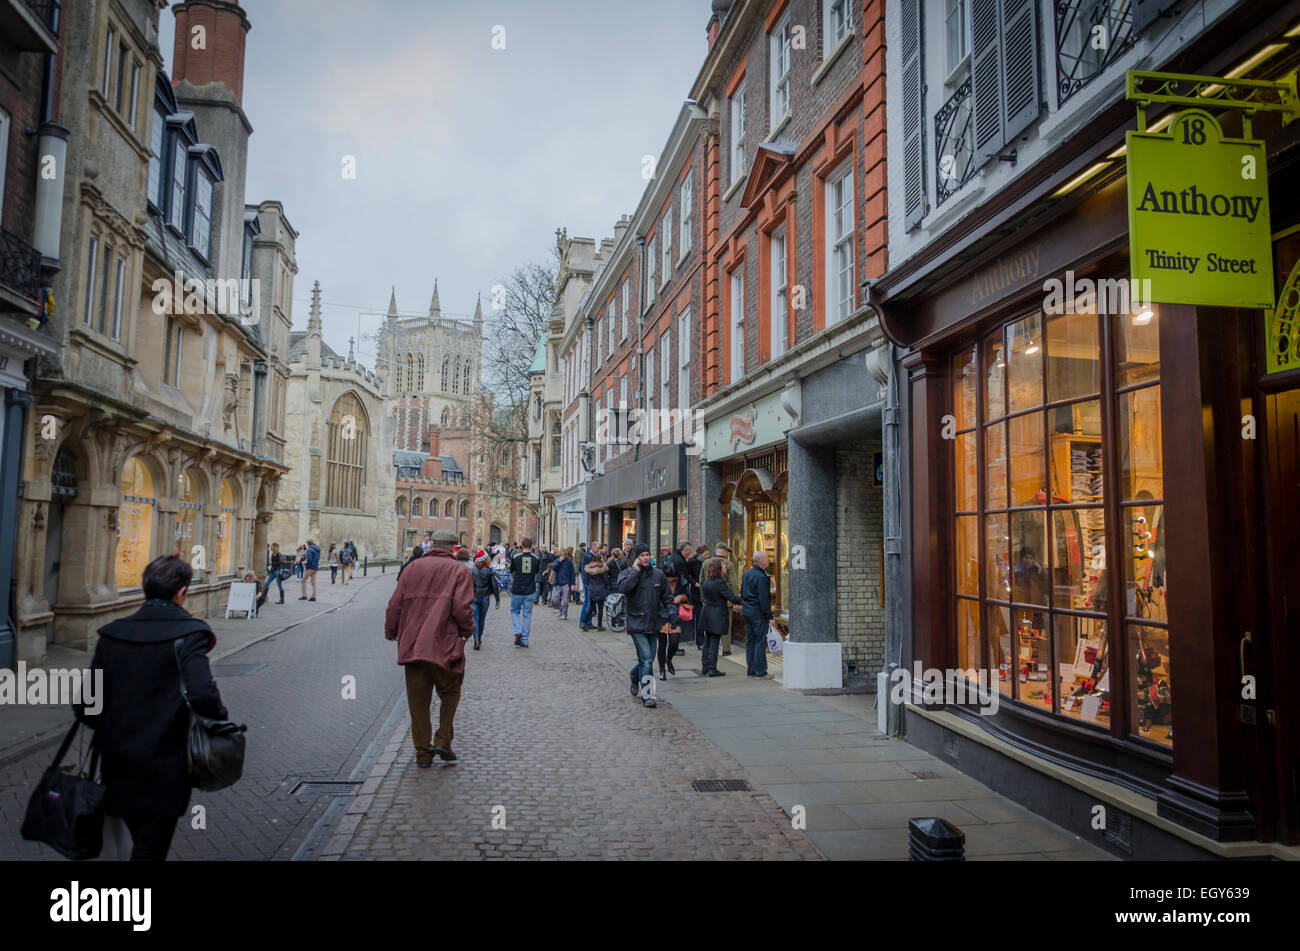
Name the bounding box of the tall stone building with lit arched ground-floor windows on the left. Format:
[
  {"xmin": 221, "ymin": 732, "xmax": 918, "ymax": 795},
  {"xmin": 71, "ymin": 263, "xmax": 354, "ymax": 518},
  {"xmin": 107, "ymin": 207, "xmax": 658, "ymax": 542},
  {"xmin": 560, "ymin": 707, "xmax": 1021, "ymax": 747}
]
[{"xmin": 16, "ymin": 0, "xmax": 291, "ymax": 663}]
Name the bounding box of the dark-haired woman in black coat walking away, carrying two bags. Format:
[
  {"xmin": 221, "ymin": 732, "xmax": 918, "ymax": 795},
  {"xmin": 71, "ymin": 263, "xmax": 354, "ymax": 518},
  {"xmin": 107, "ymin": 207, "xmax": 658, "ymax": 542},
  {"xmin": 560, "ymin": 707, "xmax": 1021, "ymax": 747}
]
[{"xmin": 78, "ymin": 555, "xmax": 228, "ymax": 861}]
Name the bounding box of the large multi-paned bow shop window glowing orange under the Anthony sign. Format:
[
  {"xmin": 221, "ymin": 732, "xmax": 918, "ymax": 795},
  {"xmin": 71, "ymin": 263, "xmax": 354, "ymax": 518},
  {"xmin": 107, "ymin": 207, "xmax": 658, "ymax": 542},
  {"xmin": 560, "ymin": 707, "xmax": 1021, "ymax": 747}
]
[{"xmin": 949, "ymin": 285, "xmax": 1173, "ymax": 746}]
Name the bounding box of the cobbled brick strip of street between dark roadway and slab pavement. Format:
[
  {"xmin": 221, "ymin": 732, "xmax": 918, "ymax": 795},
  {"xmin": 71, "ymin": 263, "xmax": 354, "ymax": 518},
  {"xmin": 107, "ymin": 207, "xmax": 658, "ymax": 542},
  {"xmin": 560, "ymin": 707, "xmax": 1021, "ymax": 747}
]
[{"xmin": 320, "ymin": 607, "xmax": 822, "ymax": 861}]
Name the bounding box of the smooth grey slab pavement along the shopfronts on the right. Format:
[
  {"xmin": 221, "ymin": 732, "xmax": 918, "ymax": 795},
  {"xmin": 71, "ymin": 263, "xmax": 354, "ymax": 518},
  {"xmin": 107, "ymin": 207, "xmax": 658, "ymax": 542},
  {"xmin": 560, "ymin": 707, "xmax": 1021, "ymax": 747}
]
[{"xmin": 584, "ymin": 623, "xmax": 1113, "ymax": 860}]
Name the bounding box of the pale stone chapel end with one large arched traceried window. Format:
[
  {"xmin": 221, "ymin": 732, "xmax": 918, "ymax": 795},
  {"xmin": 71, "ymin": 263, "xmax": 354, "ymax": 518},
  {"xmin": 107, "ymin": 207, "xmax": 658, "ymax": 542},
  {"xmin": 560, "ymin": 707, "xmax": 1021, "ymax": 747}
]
[{"xmin": 268, "ymin": 282, "xmax": 398, "ymax": 559}]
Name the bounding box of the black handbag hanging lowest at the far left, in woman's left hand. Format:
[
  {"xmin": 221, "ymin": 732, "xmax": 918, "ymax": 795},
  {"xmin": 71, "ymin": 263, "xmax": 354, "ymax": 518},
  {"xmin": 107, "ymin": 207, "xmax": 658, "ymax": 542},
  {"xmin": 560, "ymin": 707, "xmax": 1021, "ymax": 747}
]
[{"xmin": 22, "ymin": 721, "xmax": 108, "ymax": 859}]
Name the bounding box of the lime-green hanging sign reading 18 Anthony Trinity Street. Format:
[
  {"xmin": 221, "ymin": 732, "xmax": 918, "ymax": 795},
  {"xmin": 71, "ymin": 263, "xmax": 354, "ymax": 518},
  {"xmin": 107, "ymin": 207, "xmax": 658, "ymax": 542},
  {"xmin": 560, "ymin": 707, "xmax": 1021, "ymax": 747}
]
[{"xmin": 1126, "ymin": 109, "xmax": 1274, "ymax": 307}]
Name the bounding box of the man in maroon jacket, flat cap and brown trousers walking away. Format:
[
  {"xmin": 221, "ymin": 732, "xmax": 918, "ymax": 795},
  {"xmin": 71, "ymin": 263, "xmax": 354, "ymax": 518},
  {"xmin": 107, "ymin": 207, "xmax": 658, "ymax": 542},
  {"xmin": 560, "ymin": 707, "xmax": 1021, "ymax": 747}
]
[{"xmin": 384, "ymin": 531, "xmax": 475, "ymax": 769}]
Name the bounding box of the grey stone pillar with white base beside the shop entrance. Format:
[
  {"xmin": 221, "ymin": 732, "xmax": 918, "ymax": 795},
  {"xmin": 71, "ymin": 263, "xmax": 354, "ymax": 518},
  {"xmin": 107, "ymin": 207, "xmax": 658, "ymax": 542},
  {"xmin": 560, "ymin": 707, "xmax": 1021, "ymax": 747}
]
[{"xmin": 785, "ymin": 439, "xmax": 842, "ymax": 690}]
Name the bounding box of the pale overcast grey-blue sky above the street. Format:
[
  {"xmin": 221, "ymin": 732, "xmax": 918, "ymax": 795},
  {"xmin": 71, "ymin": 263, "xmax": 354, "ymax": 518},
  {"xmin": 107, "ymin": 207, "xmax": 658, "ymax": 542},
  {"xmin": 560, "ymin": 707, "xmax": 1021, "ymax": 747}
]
[{"xmin": 160, "ymin": 0, "xmax": 711, "ymax": 365}]
